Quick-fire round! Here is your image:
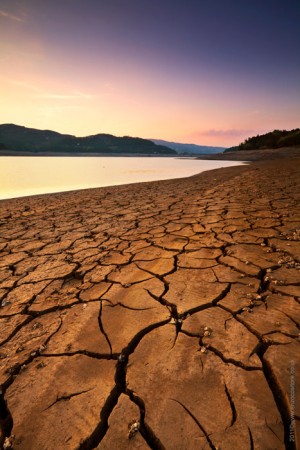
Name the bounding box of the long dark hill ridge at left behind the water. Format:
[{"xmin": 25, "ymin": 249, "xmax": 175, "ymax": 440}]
[{"xmin": 0, "ymin": 124, "xmax": 177, "ymax": 155}]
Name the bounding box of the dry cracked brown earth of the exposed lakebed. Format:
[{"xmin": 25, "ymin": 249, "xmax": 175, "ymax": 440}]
[{"xmin": 0, "ymin": 159, "xmax": 300, "ymax": 450}]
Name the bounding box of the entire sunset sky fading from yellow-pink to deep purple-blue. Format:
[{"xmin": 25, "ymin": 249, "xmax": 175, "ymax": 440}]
[{"xmin": 0, "ymin": 0, "xmax": 300, "ymax": 146}]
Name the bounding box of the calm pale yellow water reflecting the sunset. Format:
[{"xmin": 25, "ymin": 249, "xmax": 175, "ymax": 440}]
[{"xmin": 0, "ymin": 156, "xmax": 241, "ymax": 199}]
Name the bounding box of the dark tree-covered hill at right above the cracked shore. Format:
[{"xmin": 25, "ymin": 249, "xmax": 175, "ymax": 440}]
[{"xmin": 225, "ymin": 128, "xmax": 300, "ymax": 152}]
